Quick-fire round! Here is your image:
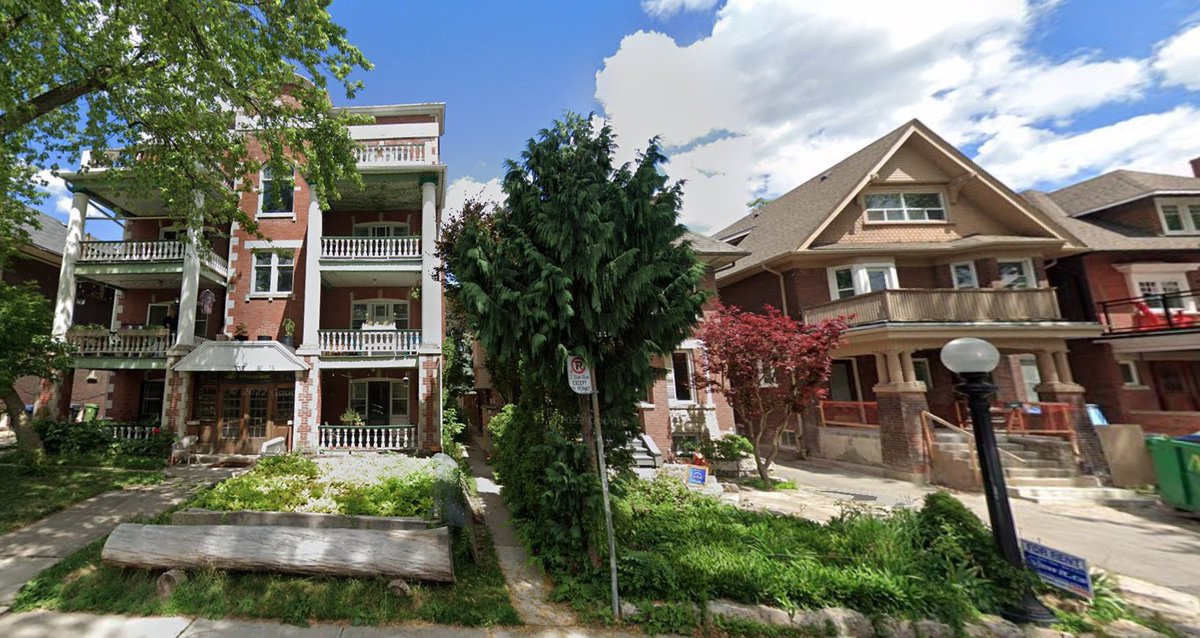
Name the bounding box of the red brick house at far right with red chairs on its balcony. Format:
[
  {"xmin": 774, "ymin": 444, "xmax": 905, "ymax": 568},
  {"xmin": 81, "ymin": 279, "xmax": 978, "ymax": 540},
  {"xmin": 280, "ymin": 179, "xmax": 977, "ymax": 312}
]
[{"xmin": 1025, "ymin": 165, "xmax": 1200, "ymax": 434}]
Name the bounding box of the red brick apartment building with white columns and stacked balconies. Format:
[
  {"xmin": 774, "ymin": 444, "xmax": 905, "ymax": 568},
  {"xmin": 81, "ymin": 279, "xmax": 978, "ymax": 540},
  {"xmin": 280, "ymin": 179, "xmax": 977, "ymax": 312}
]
[{"xmin": 43, "ymin": 103, "xmax": 446, "ymax": 453}]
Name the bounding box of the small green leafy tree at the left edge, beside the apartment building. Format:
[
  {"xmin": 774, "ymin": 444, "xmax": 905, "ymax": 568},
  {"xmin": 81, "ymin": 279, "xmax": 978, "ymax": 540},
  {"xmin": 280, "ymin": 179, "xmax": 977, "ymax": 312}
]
[{"xmin": 0, "ymin": 282, "xmax": 71, "ymax": 452}]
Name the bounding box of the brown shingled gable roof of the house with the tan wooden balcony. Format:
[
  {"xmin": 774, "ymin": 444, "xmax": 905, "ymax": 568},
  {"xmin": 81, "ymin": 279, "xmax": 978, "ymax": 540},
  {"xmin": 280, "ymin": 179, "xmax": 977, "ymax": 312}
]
[{"xmin": 713, "ymin": 119, "xmax": 1074, "ymax": 278}]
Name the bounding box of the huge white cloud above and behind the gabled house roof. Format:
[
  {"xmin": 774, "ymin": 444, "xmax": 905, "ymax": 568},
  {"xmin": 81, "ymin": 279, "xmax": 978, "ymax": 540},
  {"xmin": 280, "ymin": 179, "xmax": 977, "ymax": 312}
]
[{"xmin": 595, "ymin": 0, "xmax": 1200, "ymax": 230}]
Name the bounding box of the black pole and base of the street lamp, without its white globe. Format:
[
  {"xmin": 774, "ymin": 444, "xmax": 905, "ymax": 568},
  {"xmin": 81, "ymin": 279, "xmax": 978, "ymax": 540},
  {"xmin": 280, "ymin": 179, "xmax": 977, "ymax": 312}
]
[{"xmin": 954, "ymin": 372, "xmax": 1057, "ymax": 625}]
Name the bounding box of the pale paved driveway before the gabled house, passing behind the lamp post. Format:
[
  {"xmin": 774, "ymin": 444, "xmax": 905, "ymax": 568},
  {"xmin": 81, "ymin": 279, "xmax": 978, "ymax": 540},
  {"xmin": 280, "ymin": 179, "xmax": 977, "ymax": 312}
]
[{"xmin": 750, "ymin": 462, "xmax": 1200, "ymax": 595}]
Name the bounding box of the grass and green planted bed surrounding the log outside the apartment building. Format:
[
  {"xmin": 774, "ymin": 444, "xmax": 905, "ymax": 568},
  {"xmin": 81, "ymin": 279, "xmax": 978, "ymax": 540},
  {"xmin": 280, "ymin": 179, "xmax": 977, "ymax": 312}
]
[{"xmin": 12, "ymin": 456, "xmax": 521, "ymax": 626}]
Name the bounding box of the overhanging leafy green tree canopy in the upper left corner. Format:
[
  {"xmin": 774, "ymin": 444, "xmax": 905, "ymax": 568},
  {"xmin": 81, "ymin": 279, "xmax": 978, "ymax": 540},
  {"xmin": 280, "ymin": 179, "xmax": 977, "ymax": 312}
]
[{"xmin": 0, "ymin": 0, "xmax": 370, "ymax": 258}]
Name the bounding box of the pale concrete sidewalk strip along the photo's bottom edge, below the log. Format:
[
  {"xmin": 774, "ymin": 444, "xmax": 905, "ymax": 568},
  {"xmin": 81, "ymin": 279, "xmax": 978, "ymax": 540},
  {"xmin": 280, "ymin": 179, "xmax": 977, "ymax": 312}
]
[{"xmin": 0, "ymin": 612, "xmax": 644, "ymax": 638}]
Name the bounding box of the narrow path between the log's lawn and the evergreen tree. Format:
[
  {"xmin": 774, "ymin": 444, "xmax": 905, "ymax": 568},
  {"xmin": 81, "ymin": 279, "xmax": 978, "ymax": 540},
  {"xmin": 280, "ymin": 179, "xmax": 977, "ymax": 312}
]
[{"xmin": 467, "ymin": 440, "xmax": 578, "ymax": 623}]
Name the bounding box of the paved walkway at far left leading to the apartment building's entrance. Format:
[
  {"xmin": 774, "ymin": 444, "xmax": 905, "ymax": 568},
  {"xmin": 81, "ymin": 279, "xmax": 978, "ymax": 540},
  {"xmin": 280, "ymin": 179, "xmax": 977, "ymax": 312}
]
[{"xmin": 0, "ymin": 465, "xmax": 235, "ymax": 614}]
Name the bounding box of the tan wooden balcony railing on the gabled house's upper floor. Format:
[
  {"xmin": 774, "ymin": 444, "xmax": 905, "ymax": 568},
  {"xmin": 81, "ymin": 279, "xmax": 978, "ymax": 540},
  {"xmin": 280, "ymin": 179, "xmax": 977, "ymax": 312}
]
[{"xmin": 804, "ymin": 288, "xmax": 1062, "ymax": 326}]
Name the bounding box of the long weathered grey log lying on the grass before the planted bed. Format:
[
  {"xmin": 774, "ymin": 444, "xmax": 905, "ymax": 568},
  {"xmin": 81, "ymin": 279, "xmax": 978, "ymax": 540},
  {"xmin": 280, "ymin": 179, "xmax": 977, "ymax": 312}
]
[{"xmin": 100, "ymin": 523, "xmax": 455, "ymax": 583}]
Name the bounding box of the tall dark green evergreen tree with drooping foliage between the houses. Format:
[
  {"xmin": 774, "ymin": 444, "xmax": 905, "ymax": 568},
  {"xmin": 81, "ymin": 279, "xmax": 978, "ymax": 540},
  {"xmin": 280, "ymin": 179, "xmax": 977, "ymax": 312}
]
[{"xmin": 444, "ymin": 114, "xmax": 704, "ymax": 450}]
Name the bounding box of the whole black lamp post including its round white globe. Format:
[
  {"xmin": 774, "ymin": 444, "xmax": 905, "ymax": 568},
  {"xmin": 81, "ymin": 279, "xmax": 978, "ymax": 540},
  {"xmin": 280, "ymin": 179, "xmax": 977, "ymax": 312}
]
[{"xmin": 942, "ymin": 337, "xmax": 1057, "ymax": 625}]
